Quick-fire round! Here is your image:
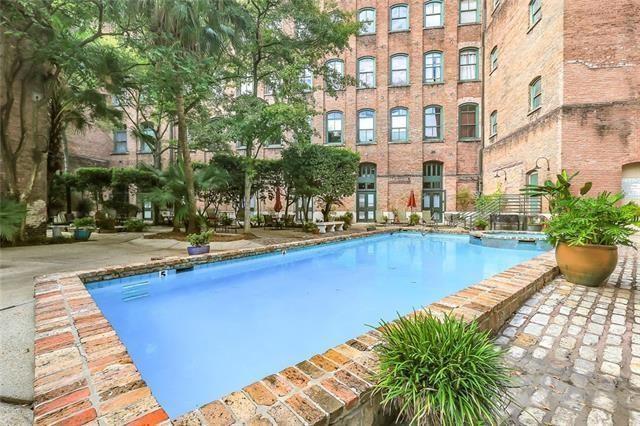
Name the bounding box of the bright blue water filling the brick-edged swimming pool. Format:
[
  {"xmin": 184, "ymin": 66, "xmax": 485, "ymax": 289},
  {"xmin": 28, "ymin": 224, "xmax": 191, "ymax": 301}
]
[{"xmin": 87, "ymin": 233, "xmax": 541, "ymax": 417}]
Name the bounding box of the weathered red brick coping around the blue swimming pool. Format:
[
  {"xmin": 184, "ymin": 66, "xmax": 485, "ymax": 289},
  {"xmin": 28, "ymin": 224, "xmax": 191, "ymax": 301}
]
[{"xmin": 34, "ymin": 227, "xmax": 558, "ymax": 425}]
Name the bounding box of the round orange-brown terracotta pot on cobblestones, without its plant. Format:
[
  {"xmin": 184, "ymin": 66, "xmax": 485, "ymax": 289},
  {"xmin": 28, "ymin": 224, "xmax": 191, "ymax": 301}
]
[{"xmin": 556, "ymin": 243, "xmax": 618, "ymax": 287}]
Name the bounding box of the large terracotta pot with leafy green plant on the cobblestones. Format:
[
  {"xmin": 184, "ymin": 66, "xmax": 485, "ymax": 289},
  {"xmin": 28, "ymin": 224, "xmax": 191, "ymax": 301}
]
[{"xmin": 544, "ymin": 192, "xmax": 637, "ymax": 287}]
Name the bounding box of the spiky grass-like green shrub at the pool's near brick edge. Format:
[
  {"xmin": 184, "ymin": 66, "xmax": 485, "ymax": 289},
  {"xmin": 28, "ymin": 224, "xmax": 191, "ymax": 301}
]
[{"xmin": 375, "ymin": 314, "xmax": 512, "ymax": 425}]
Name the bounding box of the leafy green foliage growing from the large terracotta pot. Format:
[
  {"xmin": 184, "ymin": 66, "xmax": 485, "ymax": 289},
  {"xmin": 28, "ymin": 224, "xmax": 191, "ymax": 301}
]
[{"xmin": 545, "ymin": 192, "xmax": 638, "ymax": 246}]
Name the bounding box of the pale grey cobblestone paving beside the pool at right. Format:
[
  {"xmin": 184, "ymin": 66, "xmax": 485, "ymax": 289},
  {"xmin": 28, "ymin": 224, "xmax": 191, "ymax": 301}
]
[{"xmin": 497, "ymin": 248, "xmax": 640, "ymax": 426}]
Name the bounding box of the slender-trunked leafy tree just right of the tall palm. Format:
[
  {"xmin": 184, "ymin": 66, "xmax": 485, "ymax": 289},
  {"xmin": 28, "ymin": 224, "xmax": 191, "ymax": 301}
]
[{"xmin": 209, "ymin": 0, "xmax": 359, "ymax": 232}]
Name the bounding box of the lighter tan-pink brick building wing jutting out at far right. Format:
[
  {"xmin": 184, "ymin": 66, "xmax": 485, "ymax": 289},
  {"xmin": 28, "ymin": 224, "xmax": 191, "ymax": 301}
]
[{"xmin": 483, "ymin": 0, "xmax": 640, "ymax": 202}]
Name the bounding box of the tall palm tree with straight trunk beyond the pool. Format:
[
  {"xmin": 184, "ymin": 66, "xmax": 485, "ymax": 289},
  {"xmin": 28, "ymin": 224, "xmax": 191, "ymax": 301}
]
[{"xmin": 121, "ymin": 0, "xmax": 243, "ymax": 233}]
